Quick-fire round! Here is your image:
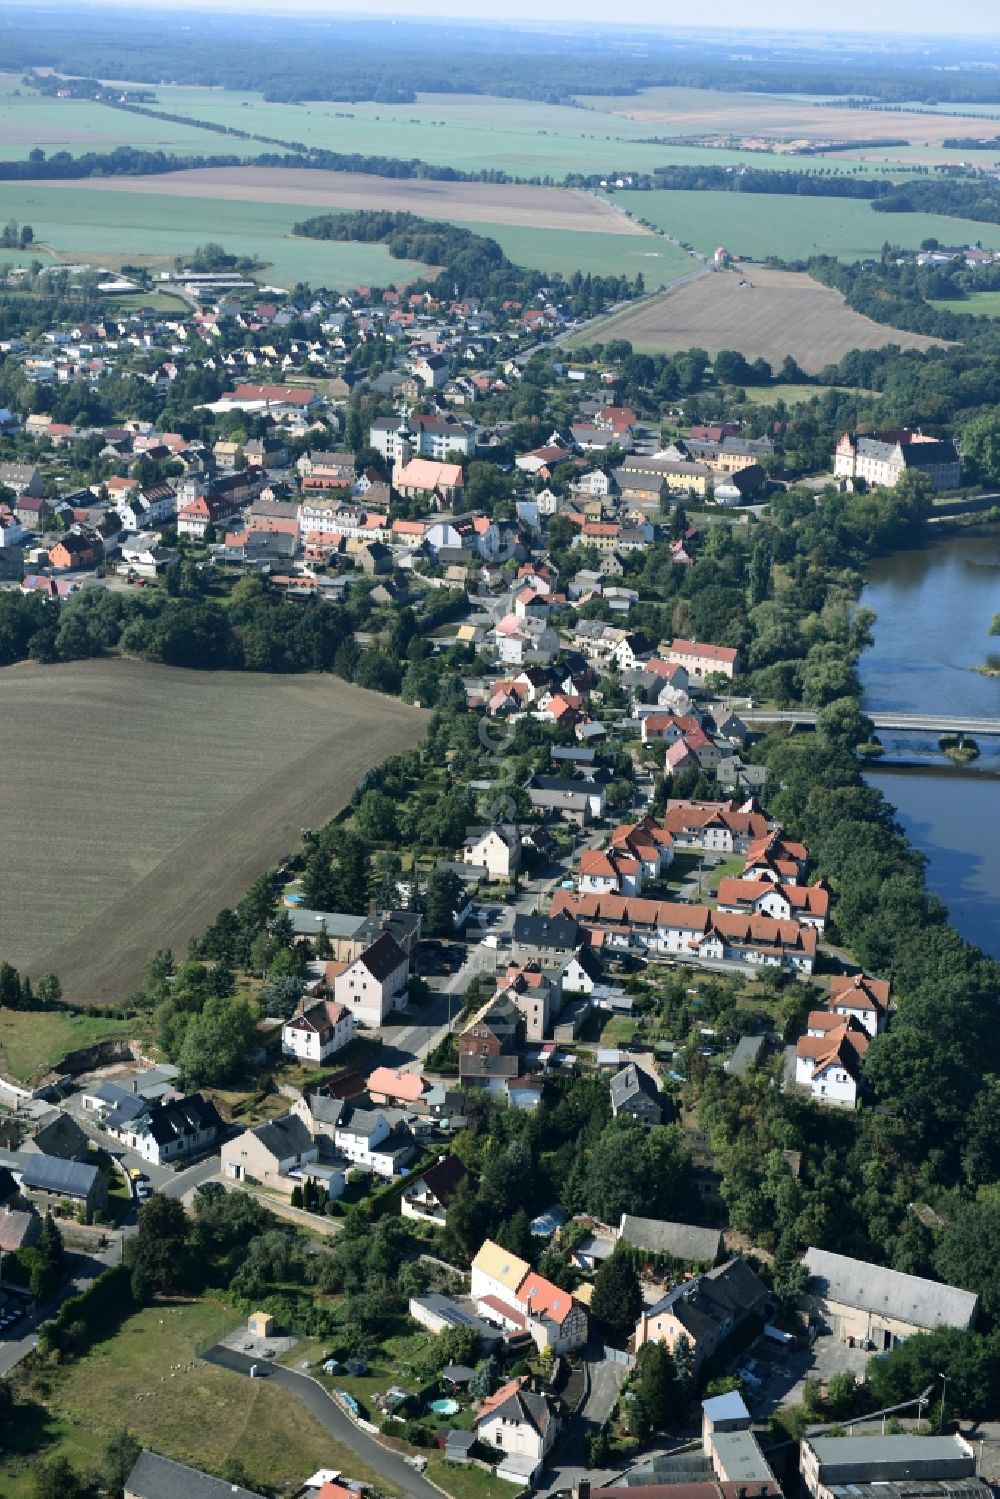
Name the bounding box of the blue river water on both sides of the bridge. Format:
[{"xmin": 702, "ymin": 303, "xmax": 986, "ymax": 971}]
[{"xmin": 861, "ymin": 531, "xmax": 1000, "ymax": 958}]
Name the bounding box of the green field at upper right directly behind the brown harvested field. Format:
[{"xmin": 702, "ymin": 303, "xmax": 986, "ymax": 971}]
[{"xmin": 619, "ymin": 192, "xmax": 1000, "ymax": 261}]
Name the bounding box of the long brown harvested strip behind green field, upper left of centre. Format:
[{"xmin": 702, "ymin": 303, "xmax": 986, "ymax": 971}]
[{"xmin": 33, "ymin": 166, "xmax": 646, "ymax": 235}]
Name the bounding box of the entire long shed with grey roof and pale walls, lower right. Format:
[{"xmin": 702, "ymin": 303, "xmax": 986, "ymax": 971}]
[{"xmin": 802, "ymin": 1249, "xmax": 979, "ymax": 1352}]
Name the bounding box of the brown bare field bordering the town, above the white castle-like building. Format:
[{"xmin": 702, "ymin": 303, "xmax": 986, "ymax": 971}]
[{"xmin": 580, "ymin": 265, "xmax": 942, "ymax": 375}]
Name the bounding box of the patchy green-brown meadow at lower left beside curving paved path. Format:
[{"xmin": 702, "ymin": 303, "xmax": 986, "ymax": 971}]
[{"xmin": 20, "ymin": 1300, "xmax": 398, "ymax": 1495}]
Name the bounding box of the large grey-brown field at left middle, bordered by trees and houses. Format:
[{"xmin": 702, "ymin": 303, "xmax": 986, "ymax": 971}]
[{"xmin": 0, "ymin": 660, "xmax": 427, "ymax": 1004}]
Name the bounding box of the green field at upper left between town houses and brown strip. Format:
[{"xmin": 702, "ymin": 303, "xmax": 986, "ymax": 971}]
[{"xmin": 3, "ymin": 183, "xmax": 421, "ymax": 289}]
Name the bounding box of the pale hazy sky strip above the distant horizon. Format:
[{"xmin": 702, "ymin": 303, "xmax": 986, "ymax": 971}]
[{"xmin": 70, "ymin": 0, "xmax": 1000, "ymax": 39}]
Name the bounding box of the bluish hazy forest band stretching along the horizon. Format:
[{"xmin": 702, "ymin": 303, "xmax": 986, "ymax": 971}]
[{"xmin": 0, "ymin": 6, "xmax": 1000, "ymax": 103}]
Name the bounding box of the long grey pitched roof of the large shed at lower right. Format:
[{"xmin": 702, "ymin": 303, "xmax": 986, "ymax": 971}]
[{"xmin": 805, "ymin": 1249, "xmax": 979, "ymax": 1330}]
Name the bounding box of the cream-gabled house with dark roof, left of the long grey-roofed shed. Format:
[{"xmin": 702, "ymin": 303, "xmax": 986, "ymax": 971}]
[{"xmin": 636, "ymin": 1258, "xmax": 769, "ymax": 1372}]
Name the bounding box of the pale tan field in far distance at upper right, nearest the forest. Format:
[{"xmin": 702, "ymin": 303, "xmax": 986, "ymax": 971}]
[{"xmin": 579, "ymin": 88, "xmax": 996, "ymax": 166}]
